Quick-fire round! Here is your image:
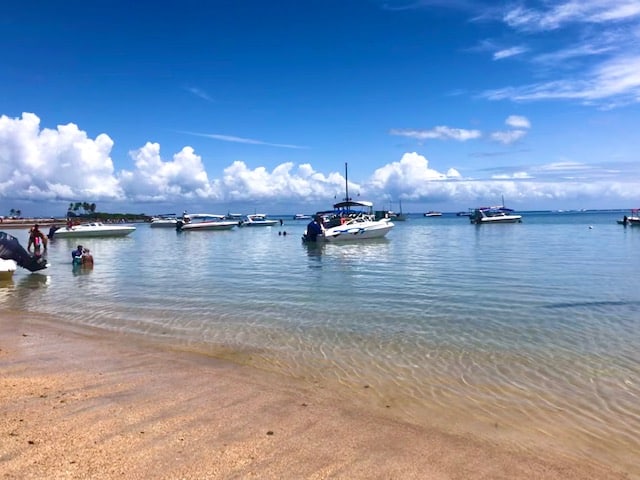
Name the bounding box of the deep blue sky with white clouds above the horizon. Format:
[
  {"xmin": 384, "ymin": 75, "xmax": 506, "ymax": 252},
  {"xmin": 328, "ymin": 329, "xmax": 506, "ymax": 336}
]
[{"xmin": 0, "ymin": 0, "xmax": 640, "ymax": 216}]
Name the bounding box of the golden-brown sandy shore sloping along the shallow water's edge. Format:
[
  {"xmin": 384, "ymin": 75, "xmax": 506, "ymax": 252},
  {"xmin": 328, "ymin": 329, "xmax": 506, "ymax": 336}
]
[{"xmin": 0, "ymin": 312, "xmax": 631, "ymax": 480}]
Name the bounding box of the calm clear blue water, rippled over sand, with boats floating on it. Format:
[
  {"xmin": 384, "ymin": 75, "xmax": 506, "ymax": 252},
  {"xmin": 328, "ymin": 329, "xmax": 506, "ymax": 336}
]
[{"xmin": 0, "ymin": 212, "xmax": 640, "ymax": 478}]
